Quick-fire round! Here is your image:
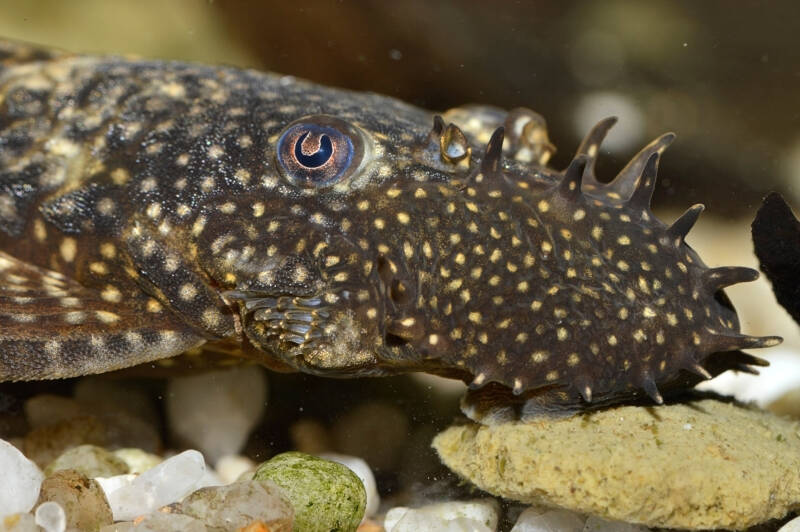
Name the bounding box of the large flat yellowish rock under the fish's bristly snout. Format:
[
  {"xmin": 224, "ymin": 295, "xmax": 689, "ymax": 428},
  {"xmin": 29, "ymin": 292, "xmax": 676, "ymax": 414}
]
[{"xmin": 433, "ymin": 399, "xmax": 800, "ymax": 529}]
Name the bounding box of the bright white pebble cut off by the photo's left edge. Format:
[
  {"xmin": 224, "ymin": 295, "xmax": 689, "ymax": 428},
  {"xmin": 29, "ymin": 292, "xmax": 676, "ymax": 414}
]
[{"xmin": 0, "ymin": 440, "xmax": 44, "ymax": 517}]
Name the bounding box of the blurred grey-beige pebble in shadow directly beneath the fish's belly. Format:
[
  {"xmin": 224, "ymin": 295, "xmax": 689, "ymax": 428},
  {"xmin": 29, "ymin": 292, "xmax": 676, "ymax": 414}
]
[{"xmin": 166, "ymin": 366, "xmax": 267, "ymax": 464}]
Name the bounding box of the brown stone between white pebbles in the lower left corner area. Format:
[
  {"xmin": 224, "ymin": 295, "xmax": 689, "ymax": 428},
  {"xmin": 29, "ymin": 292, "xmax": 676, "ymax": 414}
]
[{"xmin": 38, "ymin": 469, "xmax": 112, "ymax": 530}]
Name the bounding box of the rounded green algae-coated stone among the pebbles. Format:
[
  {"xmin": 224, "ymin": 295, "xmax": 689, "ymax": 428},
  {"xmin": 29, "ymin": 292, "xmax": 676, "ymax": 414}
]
[{"xmin": 253, "ymin": 452, "xmax": 367, "ymax": 532}]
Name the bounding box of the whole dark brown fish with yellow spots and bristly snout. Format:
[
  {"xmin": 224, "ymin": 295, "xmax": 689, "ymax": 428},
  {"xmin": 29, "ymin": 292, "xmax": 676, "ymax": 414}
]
[{"xmin": 0, "ymin": 42, "xmax": 779, "ymax": 419}]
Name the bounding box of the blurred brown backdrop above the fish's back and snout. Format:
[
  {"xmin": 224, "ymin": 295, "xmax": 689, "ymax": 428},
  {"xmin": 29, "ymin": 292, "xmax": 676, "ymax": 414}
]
[{"xmin": 0, "ymin": 0, "xmax": 800, "ymax": 218}]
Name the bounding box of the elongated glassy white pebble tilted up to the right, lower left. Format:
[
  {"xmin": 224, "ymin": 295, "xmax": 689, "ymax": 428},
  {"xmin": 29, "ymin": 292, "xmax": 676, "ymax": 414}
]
[{"xmin": 97, "ymin": 450, "xmax": 206, "ymax": 521}]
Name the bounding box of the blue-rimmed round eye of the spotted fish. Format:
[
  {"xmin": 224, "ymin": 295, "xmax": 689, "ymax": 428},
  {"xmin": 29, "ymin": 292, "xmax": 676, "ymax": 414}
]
[{"xmin": 276, "ymin": 115, "xmax": 364, "ymax": 188}]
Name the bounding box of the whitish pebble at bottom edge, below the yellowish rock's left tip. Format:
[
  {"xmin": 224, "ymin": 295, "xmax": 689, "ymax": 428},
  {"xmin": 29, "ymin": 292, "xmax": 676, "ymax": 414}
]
[{"xmin": 383, "ymin": 499, "xmax": 498, "ymax": 532}]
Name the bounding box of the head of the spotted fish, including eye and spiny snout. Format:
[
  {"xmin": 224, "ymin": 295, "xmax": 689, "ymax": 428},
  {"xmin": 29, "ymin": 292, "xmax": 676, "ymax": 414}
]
[{"xmin": 194, "ymin": 98, "xmax": 778, "ymax": 416}]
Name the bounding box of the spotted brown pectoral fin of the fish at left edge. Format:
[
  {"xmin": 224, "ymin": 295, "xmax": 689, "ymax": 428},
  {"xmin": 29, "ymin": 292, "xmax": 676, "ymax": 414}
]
[{"xmin": 0, "ymin": 252, "xmax": 205, "ymax": 382}]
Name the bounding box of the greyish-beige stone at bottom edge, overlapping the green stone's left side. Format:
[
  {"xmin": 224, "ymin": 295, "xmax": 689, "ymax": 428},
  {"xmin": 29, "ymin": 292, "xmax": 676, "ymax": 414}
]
[{"xmin": 180, "ymin": 480, "xmax": 294, "ymax": 532}]
